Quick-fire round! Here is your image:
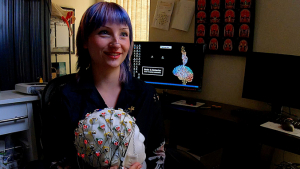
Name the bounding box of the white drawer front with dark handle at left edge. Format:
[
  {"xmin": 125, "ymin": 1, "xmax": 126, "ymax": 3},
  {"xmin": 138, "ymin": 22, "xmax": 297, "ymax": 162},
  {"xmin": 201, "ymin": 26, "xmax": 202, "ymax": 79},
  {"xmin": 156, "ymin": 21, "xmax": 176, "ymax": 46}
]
[{"xmin": 0, "ymin": 103, "xmax": 28, "ymax": 135}]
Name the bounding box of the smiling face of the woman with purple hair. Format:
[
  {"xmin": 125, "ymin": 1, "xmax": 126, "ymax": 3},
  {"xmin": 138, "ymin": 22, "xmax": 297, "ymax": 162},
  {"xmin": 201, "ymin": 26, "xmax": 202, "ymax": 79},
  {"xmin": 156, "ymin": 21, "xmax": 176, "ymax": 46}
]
[{"xmin": 84, "ymin": 23, "xmax": 130, "ymax": 69}]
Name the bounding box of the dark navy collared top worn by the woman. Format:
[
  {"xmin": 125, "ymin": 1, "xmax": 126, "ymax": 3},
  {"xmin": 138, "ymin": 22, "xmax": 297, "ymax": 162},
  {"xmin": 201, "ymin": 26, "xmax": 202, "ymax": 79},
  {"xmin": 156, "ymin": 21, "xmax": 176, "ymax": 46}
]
[{"xmin": 43, "ymin": 71, "xmax": 164, "ymax": 169}]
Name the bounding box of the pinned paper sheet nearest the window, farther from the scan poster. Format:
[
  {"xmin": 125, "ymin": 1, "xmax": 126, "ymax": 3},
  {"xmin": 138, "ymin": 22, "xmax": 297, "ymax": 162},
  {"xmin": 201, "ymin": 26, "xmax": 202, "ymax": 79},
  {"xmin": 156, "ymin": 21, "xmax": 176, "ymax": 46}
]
[{"xmin": 152, "ymin": 0, "xmax": 174, "ymax": 30}]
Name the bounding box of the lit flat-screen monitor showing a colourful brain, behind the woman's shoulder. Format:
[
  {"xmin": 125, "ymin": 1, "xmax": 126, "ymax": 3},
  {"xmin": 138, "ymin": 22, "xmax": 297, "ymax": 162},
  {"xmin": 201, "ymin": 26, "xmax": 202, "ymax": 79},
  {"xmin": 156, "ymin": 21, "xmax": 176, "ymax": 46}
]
[{"xmin": 131, "ymin": 41, "xmax": 204, "ymax": 92}]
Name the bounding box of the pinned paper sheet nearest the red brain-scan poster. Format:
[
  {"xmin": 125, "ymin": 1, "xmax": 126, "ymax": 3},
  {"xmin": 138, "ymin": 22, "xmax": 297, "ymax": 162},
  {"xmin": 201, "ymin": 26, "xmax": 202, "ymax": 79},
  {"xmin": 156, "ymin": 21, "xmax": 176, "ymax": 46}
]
[{"xmin": 171, "ymin": 0, "xmax": 195, "ymax": 31}]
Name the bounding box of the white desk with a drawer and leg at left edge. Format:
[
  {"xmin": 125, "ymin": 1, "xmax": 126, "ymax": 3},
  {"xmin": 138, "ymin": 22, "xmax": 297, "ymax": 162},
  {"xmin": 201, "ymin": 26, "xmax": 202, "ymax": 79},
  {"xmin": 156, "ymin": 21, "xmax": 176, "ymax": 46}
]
[{"xmin": 0, "ymin": 90, "xmax": 39, "ymax": 161}]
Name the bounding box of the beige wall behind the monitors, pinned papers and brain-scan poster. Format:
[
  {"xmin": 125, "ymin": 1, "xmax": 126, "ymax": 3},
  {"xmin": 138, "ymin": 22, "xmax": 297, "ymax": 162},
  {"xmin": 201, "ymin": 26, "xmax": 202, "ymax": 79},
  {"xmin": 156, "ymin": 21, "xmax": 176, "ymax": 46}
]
[{"xmin": 149, "ymin": 0, "xmax": 300, "ymax": 110}]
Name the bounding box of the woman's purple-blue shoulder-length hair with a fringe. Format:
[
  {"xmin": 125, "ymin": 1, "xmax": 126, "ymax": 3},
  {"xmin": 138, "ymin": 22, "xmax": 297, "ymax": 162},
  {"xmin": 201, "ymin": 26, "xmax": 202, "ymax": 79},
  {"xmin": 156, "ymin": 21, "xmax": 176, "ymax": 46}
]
[{"xmin": 76, "ymin": 2, "xmax": 133, "ymax": 83}]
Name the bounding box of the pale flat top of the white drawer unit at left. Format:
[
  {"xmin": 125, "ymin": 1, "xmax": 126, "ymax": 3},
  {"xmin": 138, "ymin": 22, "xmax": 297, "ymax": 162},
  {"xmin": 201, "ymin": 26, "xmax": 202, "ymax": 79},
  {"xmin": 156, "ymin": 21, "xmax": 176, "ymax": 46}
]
[{"xmin": 0, "ymin": 90, "xmax": 39, "ymax": 105}]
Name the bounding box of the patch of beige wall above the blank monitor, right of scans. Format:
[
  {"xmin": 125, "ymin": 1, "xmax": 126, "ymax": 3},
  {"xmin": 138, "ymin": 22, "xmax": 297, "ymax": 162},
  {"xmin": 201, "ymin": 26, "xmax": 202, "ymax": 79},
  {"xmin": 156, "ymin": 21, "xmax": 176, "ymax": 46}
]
[{"xmin": 254, "ymin": 0, "xmax": 300, "ymax": 56}]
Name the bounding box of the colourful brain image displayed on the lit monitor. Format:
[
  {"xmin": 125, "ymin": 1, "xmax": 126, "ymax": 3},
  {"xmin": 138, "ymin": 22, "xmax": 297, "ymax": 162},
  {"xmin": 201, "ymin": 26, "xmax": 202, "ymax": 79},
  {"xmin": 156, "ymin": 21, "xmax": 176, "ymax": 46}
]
[{"xmin": 173, "ymin": 46, "xmax": 194, "ymax": 85}]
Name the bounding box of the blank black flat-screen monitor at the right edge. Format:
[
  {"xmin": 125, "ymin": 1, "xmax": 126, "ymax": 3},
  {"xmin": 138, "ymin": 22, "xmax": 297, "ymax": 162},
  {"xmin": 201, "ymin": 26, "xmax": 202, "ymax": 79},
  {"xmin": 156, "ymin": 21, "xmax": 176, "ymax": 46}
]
[{"xmin": 243, "ymin": 52, "xmax": 300, "ymax": 112}]
